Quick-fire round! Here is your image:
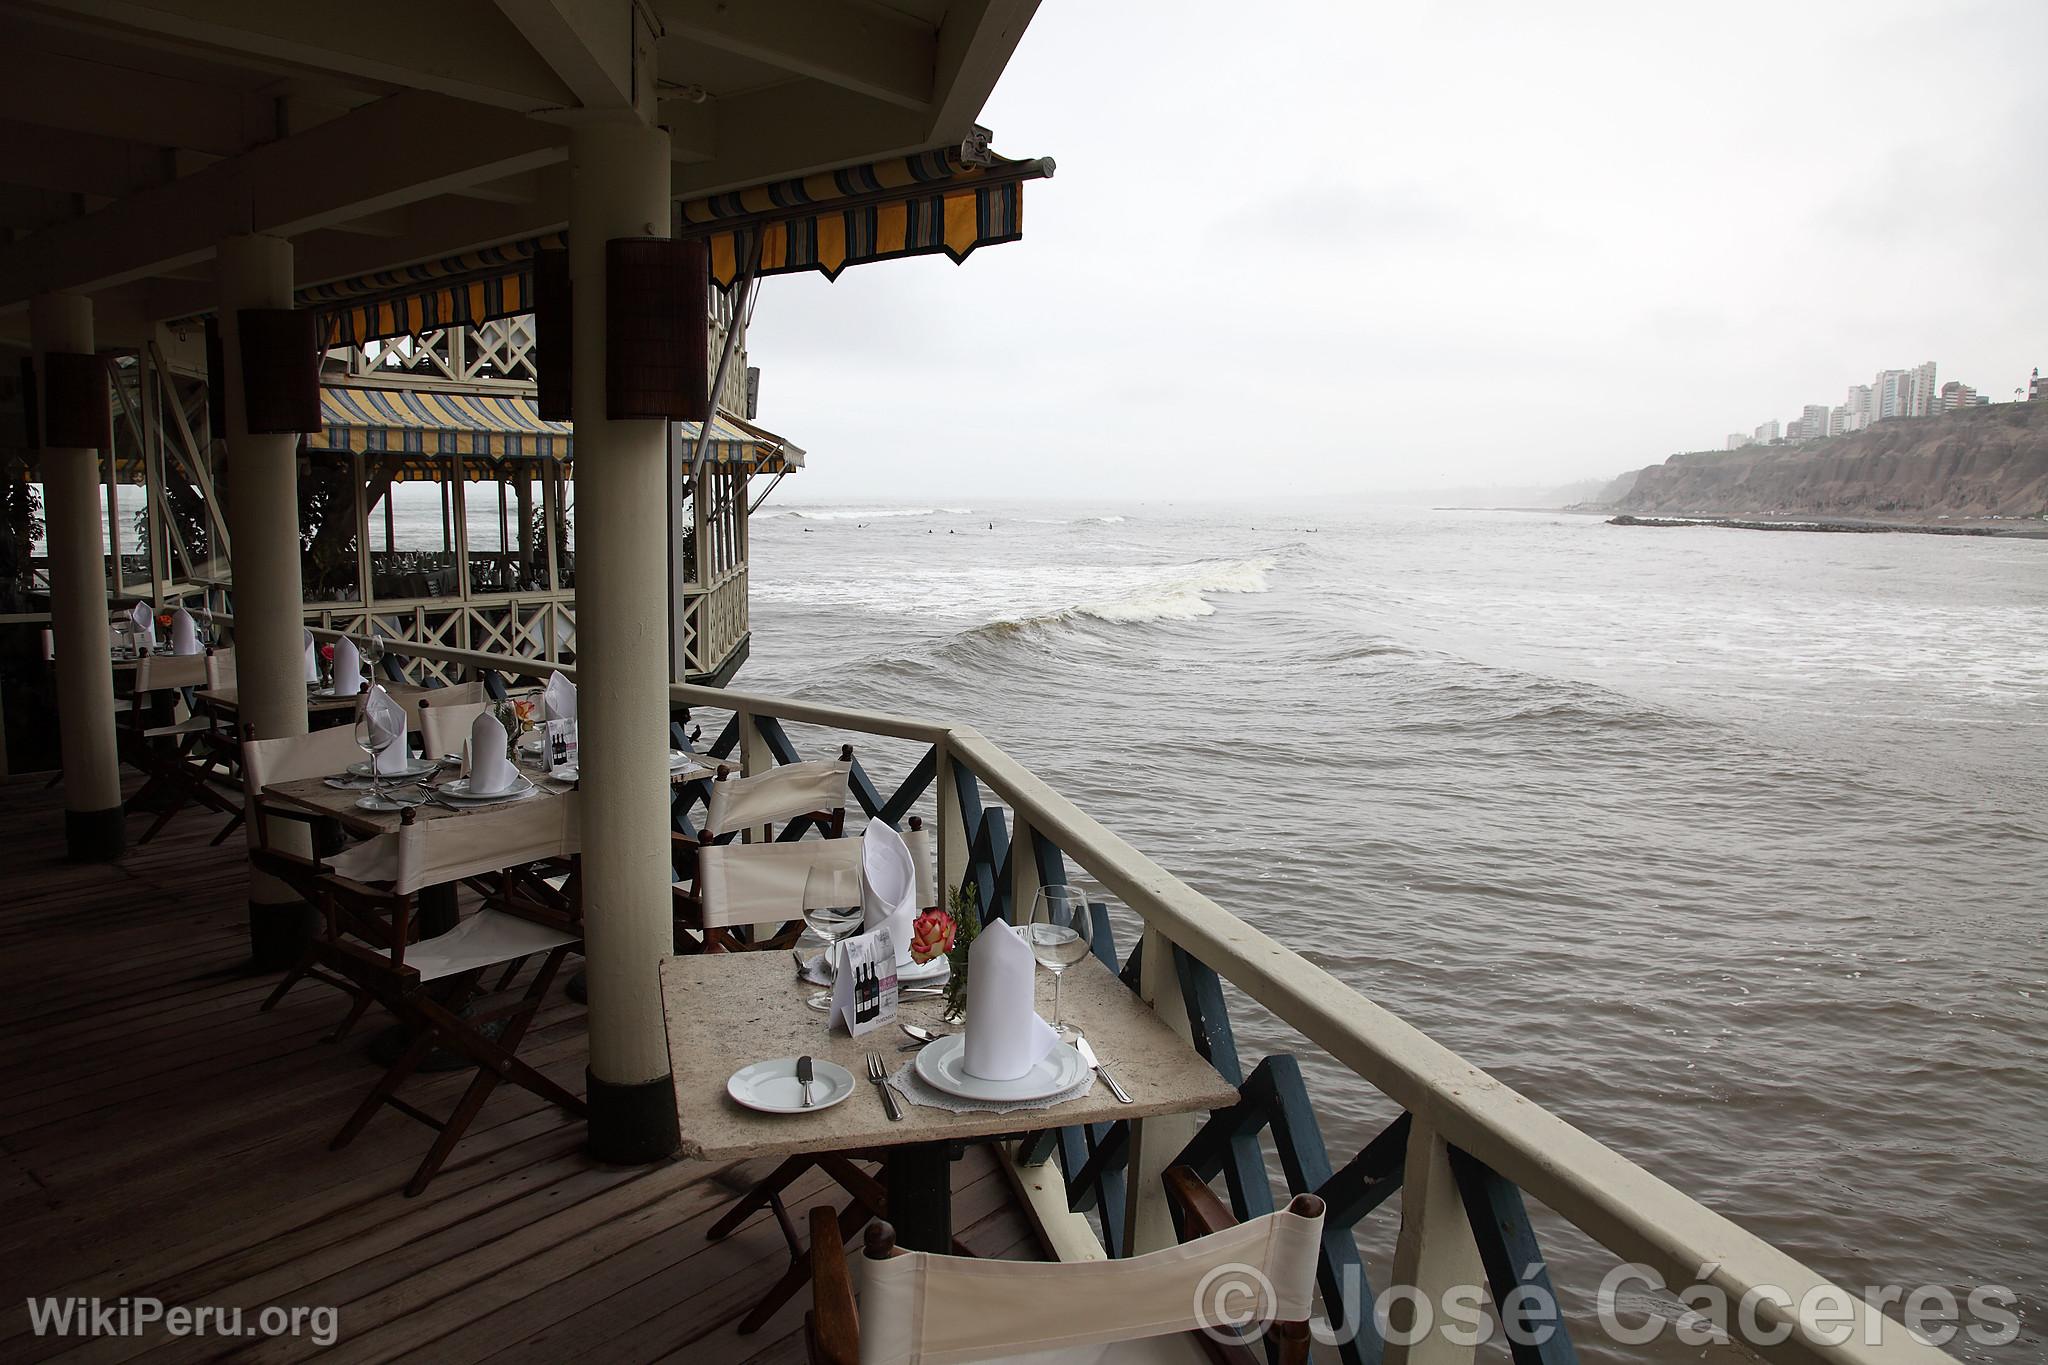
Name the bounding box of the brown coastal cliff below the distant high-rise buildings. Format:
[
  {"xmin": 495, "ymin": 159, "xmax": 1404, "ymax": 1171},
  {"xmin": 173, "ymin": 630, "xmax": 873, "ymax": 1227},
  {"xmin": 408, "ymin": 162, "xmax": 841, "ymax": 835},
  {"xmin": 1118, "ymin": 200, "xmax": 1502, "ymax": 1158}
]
[{"xmin": 1610, "ymin": 403, "xmax": 2048, "ymax": 520}]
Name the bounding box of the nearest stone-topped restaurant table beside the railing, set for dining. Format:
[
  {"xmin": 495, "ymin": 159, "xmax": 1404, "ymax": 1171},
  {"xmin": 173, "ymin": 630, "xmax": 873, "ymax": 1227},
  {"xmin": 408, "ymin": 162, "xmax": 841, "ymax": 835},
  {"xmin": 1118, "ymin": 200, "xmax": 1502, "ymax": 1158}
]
[{"xmin": 662, "ymin": 952, "xmax": 1237, "ymax": 1252}]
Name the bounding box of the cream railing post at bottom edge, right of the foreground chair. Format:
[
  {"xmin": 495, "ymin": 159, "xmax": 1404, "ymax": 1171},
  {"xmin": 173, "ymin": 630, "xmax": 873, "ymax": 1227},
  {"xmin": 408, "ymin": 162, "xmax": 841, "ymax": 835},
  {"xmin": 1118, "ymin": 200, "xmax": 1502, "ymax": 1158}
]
[{"xmin": 1384, "ymin": 1115, "xmax": 1487, "ymax": 1365}]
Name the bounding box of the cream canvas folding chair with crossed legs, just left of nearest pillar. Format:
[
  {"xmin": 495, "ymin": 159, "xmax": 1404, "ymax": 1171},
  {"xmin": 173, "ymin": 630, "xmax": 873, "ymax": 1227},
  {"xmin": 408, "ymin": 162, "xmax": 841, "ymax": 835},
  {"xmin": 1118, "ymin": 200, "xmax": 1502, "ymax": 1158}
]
[{"xmin": 309, "ymin": 794, "xmax": 588, "ymax": 1195}]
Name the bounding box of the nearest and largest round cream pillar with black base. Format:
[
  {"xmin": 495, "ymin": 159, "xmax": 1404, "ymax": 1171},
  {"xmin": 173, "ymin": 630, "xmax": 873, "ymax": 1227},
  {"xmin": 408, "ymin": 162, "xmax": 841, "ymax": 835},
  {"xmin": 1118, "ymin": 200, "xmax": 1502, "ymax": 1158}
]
[{"xmin": 569, "ymin": 121, "xmax": 678, "ymax": 1162}]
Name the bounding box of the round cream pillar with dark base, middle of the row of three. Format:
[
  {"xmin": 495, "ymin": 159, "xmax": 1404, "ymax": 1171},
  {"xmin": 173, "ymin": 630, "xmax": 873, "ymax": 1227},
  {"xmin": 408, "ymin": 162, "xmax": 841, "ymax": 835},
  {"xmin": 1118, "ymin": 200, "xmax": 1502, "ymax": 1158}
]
[{"xmin": 215, "ymin": 235, "xmax": 311, "ymax": 968}]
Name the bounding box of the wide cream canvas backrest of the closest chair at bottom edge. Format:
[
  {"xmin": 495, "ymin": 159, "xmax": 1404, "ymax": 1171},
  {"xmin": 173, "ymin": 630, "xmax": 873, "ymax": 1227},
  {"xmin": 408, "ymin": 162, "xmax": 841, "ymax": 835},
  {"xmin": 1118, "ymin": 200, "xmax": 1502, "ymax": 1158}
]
[{"xmin": 860, "ymin": 1207, "xmax": 1323, "ymax": 1365}]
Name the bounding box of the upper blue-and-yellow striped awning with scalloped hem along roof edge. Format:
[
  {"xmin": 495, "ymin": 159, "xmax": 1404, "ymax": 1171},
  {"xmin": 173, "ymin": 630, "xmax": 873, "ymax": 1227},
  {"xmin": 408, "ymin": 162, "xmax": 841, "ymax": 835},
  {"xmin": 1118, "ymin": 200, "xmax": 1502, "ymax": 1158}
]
[{"xmin": 299, "ymin": 147, "xmax": 1053, "ymax": 346}]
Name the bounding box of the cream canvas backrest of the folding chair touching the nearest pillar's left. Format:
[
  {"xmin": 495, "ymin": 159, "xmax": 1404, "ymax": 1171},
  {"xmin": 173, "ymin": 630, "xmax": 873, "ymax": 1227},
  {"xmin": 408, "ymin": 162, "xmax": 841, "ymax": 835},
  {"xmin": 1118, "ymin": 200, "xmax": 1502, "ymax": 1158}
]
[{"xmin": 328, "ymin": 792, "xmax": 582, "ymax": 896}]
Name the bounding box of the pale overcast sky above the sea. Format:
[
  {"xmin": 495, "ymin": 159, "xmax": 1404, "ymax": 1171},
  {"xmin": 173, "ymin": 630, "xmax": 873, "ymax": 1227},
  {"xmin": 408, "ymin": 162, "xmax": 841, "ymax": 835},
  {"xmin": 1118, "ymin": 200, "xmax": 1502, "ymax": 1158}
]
[{"xmin": 750, "ymin": 0, "xmax": 2048, "ymax": 501}]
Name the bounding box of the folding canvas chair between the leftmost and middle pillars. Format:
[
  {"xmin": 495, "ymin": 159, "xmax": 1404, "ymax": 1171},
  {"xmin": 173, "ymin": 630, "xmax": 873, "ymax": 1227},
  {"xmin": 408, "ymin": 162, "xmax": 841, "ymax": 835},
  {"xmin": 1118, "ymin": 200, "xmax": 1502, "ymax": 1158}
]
[{"xmin": 127, "ymin": 655, "xmax": 242, "ymax": 843}]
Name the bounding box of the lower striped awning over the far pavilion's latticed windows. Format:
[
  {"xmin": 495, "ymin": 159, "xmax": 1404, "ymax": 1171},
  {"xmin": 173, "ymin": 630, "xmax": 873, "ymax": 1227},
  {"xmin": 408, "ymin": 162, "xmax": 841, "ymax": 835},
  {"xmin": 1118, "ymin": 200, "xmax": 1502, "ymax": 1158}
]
[{"xmin": 305, "ymin": 387, "xmax": 803, "ymax": 479}]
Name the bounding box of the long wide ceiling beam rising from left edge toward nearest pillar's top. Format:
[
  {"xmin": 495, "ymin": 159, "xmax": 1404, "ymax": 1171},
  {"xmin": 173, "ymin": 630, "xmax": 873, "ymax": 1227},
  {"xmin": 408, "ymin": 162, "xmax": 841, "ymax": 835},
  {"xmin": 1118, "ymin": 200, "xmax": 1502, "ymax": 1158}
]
[{"xmin": 0, "ymin": 90, "xmax": 567, "ymax": 303}]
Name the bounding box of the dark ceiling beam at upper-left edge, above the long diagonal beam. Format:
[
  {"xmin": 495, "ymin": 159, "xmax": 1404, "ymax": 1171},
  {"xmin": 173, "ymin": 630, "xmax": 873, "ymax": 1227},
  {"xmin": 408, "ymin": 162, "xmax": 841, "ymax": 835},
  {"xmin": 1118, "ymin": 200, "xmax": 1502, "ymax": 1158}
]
[{"xmin": 0, "ymin": 41, "xmax": 276, "ymax": 156}]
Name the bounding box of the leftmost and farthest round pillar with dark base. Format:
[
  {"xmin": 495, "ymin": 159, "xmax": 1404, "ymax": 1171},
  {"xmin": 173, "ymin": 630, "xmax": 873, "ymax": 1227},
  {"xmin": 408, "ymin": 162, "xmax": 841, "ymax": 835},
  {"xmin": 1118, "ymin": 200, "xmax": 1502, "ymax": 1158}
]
[{"xmin": 29, "ymin": 295, "xmax": 127, "ymax": 862}]
